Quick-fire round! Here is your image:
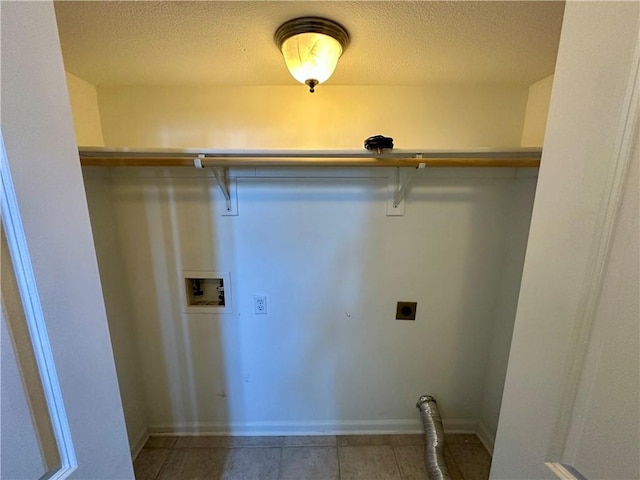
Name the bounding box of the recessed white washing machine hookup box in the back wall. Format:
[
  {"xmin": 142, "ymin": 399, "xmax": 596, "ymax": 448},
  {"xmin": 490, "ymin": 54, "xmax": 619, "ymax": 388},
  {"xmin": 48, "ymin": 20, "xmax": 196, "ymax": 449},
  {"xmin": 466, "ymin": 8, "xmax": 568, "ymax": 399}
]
[{"xmin": 182, "ymin": 271, "xmax": 233, "ymax": 313}]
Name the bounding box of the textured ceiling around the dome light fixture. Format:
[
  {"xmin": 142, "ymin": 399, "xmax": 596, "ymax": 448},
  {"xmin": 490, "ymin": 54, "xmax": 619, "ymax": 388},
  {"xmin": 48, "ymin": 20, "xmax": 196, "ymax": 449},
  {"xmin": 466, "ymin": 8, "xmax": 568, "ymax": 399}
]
[{"xmin": 55, "ymin": 1, "xmax": 564, "ymax": 86}]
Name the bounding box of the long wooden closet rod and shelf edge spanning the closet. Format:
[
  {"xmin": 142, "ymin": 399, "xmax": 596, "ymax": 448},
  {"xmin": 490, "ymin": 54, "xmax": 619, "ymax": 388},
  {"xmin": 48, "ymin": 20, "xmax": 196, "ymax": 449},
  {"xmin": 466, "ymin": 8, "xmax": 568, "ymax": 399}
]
[{"xmin": 79, "ymin": 147, "xmax": 542, "ymax": 167}]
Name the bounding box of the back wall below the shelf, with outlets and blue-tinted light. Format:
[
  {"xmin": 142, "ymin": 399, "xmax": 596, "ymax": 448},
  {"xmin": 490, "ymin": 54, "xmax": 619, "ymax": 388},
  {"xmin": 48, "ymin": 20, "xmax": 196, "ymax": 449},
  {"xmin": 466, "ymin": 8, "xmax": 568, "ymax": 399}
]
[{"xmin": 87, "ymin": 164, "xmax": 535, "ymax": 434}]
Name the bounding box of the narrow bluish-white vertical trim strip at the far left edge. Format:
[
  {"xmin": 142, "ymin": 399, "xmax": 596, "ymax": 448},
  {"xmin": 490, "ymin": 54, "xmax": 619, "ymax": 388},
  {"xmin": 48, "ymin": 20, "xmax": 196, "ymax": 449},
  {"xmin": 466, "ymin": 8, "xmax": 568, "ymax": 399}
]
[{"xmin": 0, "ymin": 131, "xmax": 78, "ymax": 480}]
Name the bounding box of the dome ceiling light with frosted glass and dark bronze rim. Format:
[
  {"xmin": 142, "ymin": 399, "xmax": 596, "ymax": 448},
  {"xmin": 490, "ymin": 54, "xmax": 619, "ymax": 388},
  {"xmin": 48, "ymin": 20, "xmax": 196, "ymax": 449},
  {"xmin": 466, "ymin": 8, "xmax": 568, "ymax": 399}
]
[{"xmin": 274, "ymin": 17, "xmax": 349, "ymax": 93}]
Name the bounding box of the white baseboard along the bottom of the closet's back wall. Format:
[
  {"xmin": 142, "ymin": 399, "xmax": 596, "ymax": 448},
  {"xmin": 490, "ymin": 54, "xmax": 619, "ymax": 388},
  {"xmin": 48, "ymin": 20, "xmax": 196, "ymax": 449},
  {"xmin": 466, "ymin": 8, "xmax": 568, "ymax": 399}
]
[{"xmin": 149, "ymin": 418, "xmax": 478, "ymax": 436}]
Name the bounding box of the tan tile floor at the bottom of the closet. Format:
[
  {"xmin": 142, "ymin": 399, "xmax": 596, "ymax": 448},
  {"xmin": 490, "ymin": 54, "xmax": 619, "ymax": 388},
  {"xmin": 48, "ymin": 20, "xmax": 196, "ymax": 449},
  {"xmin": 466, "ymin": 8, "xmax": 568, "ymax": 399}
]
[{"xmin": 134, "ymin": 434, "xmax": 491, "ymax": 480}]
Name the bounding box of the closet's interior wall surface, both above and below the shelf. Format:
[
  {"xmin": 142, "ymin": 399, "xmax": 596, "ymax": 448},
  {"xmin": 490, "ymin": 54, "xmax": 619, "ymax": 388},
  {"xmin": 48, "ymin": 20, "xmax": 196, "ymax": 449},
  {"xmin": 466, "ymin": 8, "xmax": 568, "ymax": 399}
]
[{"xmin": 70, "ymin": 80, "xmax": 552, "ymax": 451}]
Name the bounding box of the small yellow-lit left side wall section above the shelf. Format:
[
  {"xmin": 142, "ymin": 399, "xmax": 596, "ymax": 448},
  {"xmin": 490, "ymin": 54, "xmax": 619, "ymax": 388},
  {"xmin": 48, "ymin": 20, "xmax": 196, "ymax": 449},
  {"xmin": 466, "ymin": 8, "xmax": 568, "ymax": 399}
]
[{"xmin": 67, "ymin": 72, "xmax": 104, "ymax": 146}]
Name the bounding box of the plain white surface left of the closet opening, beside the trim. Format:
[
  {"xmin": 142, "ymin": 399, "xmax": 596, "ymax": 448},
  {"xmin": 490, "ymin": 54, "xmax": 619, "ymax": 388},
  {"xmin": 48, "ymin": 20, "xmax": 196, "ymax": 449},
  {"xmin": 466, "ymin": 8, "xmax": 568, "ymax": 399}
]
[{"xmin": 0, "ymin": 2, "xmax": 133, "ymax": 480}]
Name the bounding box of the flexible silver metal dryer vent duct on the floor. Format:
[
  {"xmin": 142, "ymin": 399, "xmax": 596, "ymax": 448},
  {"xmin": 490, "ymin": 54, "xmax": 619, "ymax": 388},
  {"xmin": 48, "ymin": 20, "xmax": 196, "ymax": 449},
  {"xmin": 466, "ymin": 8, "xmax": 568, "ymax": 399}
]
[{"xmin": 416, "ymin": 395, "xmax": 451, "ymax": 480}]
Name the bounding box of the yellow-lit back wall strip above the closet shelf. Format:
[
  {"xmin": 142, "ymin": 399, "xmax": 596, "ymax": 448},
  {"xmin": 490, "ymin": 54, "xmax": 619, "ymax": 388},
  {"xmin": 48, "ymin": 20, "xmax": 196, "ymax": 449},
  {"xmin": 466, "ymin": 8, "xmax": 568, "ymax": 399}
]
[{"xmin": 98, "ymin": 85, "xmax": 527, "ymax": 149}]
